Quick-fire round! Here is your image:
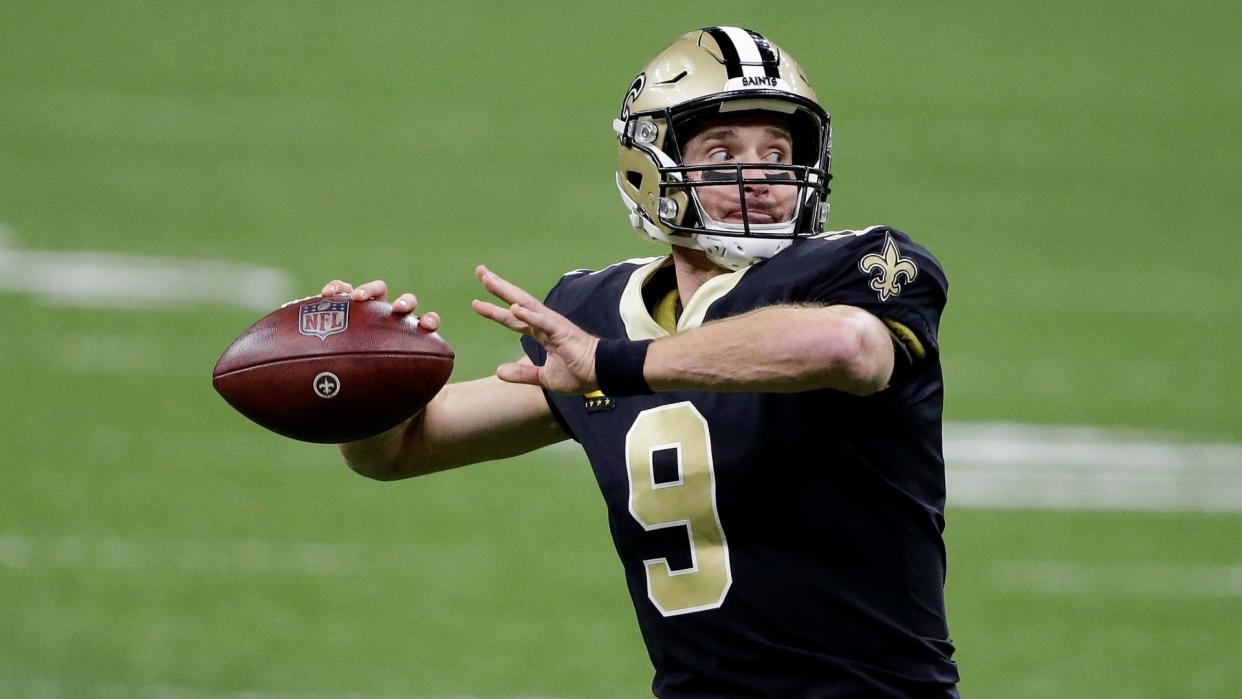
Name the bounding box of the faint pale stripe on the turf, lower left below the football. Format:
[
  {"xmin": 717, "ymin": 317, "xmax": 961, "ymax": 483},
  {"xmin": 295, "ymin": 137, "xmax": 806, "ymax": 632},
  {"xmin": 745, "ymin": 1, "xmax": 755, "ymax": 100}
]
[{"xmin": 0, "ymin": 534, "xmax": 360, "ymax": 576}]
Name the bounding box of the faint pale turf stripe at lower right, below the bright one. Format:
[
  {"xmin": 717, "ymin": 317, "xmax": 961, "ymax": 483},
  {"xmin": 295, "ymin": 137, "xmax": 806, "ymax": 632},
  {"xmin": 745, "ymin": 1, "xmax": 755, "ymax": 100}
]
[{"xmin": 987, "ymin": 561, "xmax": 1242, "ymax": 600}]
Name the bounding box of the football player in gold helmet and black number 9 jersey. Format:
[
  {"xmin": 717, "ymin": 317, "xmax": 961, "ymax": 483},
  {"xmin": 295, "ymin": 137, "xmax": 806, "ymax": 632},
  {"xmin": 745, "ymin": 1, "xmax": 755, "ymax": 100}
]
[{"xmin": 323, "ymin": 27, "xmax": 958, "ymax": 699}]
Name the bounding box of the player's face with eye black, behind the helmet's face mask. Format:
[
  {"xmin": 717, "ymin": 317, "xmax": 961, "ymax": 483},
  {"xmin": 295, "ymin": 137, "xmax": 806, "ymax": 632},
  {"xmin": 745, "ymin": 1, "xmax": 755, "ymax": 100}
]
[{"xmin": 682, "ymin": 114, "xmax": 797, "ymax": 225}]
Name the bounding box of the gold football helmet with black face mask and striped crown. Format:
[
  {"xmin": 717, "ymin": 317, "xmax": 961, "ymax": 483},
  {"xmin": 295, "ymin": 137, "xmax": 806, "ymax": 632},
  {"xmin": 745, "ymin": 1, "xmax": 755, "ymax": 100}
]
[{"xmin": 612, "ymin": 27, "xmax": 832, "ymax": 269}]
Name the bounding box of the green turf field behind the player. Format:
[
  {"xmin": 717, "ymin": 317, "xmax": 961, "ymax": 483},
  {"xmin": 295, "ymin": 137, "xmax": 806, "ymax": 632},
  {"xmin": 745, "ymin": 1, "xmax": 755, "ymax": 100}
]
[{"xmin": 0, "ymin": 0, "xmax": 1242, "ymax": 699}]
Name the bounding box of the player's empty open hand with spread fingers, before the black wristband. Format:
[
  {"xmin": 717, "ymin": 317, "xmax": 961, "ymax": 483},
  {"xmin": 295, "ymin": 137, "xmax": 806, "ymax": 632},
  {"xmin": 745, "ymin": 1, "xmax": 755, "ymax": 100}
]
[{"xmin": 471, "ymin": 264, "xmax": 600, "ymax": 395}]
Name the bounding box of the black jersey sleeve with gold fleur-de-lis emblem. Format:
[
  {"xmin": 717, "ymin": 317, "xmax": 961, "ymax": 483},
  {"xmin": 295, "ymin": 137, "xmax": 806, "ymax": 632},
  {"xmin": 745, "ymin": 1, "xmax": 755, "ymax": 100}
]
[{"xmin": 806, "ymin": 227, "xmax": 949, "ymax": 364}]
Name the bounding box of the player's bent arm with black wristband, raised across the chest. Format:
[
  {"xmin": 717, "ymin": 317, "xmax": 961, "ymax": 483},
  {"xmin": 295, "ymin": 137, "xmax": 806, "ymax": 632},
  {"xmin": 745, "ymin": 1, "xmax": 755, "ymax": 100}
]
[{"xmin": 473, "ymin": 267, "xmax": 895, "ymax": 395}]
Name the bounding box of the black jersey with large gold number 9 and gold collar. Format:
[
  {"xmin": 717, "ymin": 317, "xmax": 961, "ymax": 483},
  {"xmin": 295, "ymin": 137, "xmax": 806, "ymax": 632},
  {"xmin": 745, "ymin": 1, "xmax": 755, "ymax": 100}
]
[{"xmin": 524, "ymin": 227, "xmax": 958, "ymax": 698}]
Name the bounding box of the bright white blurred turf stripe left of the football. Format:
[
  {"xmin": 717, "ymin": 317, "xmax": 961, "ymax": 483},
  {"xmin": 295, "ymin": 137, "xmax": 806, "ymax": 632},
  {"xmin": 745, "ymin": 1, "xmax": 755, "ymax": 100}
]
[{"xmin": 0, "ymin": 224, "xmax": 293, "ymax": 310}]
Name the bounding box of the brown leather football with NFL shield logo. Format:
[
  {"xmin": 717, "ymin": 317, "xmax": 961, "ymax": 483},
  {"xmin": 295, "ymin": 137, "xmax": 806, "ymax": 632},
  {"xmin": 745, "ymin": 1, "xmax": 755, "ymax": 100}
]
[{"xmin": 211, "ymin": 295, "xmax": 453, "ymax": 443}]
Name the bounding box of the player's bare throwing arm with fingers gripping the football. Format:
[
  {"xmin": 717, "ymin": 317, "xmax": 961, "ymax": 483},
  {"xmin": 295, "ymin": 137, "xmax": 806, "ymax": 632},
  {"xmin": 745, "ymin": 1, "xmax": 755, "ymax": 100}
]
[{"xmin": 323, "ymin": 281, "xmax": 566, "ymax": 480}]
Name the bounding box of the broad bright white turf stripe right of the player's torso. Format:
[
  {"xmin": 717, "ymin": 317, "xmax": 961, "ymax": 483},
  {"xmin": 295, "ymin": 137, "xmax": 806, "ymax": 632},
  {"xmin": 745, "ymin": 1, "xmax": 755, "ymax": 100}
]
[{"xmin": 553, "ymin": 422, "xmax": 1242, "ymax": 512}]
